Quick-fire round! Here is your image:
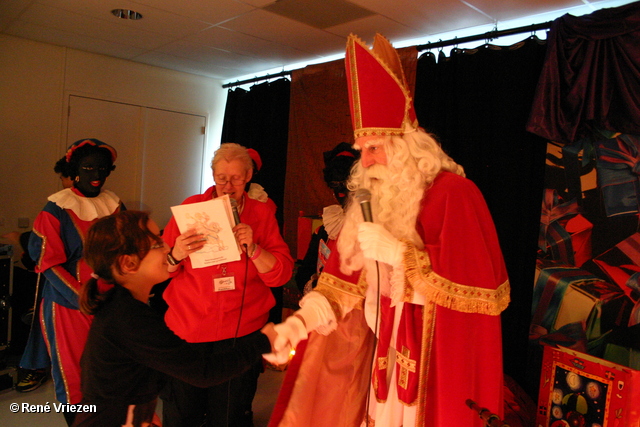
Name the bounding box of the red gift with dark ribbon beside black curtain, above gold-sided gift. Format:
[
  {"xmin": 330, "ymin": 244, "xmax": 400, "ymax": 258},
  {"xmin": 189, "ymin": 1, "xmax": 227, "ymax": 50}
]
[{"xmin": 538, "ymin": 189, "xmax": 593, "ymax": 266}]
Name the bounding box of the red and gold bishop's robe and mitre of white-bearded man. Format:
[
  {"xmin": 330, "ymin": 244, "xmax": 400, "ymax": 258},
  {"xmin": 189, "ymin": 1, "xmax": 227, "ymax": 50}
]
[{"xmin": 271, "ymin": 35, "xmax": 509, "ymax": 427}]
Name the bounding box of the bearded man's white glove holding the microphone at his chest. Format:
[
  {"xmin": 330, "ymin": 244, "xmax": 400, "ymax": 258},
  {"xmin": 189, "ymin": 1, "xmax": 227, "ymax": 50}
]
[{"xmin": 358, "ymin": 222, "xmax": 406, "ymax": 267}]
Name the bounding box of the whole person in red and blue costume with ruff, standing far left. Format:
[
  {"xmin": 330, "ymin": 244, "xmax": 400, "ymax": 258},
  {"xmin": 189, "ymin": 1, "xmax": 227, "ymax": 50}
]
[{"xmin": 29, "ymin": 139, "xmax": 124, "ymax": 425}]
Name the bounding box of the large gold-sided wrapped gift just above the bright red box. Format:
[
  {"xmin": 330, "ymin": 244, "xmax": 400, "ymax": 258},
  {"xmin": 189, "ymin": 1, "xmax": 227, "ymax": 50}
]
[{"xmin": 531, "ymin": 260, "xmax": 632, "ymax": 341}]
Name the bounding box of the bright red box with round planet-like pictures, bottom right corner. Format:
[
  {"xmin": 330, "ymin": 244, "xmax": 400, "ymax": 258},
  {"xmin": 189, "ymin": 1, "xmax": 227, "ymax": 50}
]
[{"xmin": 536, "ymin": 346, "xmax": 640, "ymax": 427}]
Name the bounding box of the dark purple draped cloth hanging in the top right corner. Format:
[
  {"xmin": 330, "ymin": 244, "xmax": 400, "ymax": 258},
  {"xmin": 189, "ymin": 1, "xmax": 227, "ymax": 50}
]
[{"xmin": 527, "ymin": 2, "xmax": 640, "ymax": 144}]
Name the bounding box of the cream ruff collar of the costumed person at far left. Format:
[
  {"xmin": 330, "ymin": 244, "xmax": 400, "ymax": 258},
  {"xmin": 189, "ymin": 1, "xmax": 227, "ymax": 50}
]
[{"xmin": 49, "ymin": 188, "xmax": 120, "ymax": 221}]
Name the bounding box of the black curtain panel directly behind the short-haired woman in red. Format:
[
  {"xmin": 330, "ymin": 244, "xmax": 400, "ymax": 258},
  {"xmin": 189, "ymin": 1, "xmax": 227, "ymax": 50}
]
[{"xmin": 221, "ymin": 79, "xmax": 291, "ymax": 231}]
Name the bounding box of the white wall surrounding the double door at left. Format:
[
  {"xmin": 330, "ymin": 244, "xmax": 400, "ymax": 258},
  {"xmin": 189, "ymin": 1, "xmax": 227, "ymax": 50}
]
[{"xmin": 0, "ymin": 35, "xmax": 227, "ymax": 234}]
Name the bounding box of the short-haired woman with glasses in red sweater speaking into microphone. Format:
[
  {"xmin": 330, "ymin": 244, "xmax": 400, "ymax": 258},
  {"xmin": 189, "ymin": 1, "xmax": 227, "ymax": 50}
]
[{"xmin": 161, "ymin": 143, "xmax": 293, "ymax": 427}]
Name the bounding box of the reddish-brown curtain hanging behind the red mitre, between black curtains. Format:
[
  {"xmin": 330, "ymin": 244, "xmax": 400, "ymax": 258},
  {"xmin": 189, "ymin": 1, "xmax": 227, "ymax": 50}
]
[{"xmin": 284, "ymin": 47, "xmax": 418, "ymax": 256}]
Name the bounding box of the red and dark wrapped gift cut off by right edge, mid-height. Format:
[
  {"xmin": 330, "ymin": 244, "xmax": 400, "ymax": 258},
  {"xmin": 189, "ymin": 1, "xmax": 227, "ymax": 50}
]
[{"xmin": 583, "ymin": 232, "xmax": 640, "ymax": 301}]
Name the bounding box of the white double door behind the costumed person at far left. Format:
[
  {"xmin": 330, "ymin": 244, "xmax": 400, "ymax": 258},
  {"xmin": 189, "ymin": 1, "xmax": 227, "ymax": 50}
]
[{"xmin": 65, "ymin": 96, "xmax": 206, "ymax": 228}]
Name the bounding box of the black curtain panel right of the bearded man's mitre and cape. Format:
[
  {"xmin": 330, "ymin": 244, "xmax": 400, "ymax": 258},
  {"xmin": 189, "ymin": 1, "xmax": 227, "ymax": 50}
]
[{"xmin": 415, "ymin": 37, "xmax": 546, "ymax": 394}]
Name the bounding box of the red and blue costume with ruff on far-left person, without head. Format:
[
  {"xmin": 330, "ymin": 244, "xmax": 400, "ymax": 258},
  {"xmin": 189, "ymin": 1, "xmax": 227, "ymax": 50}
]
[{"xmin": 29, "ymin": 188, "xmax": 123, "ymax": 404}]
